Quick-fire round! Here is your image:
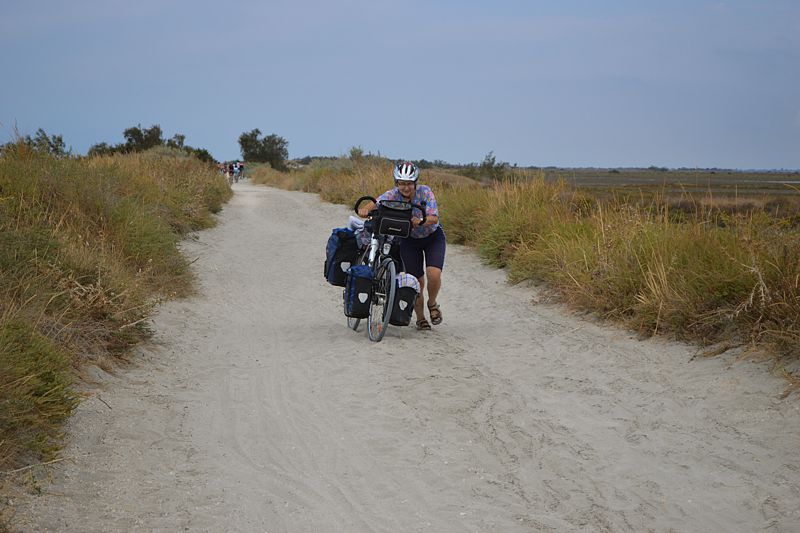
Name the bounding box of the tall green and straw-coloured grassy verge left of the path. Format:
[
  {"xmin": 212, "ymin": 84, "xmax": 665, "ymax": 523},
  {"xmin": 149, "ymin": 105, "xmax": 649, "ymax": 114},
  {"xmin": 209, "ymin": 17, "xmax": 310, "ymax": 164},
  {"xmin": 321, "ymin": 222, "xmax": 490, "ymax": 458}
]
[{"xmin": 0, "ymin": 145, "xmax": 231, "ymax": 472}]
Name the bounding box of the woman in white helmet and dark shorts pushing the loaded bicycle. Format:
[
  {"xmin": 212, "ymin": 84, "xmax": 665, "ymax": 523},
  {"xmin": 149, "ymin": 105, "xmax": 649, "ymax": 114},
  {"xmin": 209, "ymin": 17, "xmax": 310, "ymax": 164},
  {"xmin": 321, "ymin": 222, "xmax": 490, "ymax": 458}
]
[{"xmin": 358, "ymin": 162, "xmax": 447, "ymax": 330}]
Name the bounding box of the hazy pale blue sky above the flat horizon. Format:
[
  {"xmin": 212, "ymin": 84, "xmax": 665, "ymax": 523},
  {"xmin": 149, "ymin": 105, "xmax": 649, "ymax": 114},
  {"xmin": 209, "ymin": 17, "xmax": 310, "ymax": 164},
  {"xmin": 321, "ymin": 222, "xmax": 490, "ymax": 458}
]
[{"xmin": 0, "ymin": 0, "xmax": 800, "ymax": 169}]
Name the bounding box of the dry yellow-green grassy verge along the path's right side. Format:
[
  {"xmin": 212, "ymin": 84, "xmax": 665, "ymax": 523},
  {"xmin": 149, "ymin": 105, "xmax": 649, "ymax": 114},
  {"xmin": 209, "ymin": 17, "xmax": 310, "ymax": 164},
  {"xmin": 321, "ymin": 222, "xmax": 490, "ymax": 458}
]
[{"xmin": 253, "ymin": 158, "xmax": 800, "ymax": 366}]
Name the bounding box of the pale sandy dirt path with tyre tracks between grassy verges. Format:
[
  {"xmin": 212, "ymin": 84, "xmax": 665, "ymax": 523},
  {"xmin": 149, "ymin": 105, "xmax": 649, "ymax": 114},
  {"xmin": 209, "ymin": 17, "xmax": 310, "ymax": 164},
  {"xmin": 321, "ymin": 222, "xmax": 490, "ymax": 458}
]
[{"xmin": 17, "ymin": 183, "xmax": 800, "ymax": 533}]
